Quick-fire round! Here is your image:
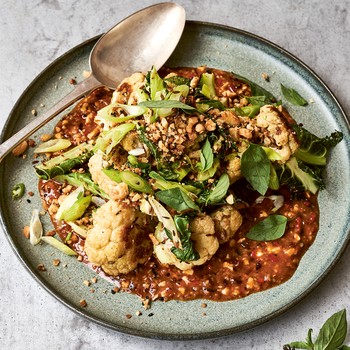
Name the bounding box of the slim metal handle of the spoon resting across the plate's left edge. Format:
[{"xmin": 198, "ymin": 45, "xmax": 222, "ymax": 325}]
[{"xmin": 0, "ymin": 75, "xmax": 102, "ymax": 163}]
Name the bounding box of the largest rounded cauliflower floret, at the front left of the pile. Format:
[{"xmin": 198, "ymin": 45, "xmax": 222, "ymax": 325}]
[{"xmin": 84, "ymin": 200, "xmax": 152, "ymax": 276}]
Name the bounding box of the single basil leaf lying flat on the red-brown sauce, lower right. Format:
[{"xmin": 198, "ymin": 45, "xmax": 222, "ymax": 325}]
[{"xmin": 247, "ymin": 215, "xmax": 287, "ymax": 241}]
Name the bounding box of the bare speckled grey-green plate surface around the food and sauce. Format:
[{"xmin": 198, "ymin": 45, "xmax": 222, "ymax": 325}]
[{"xmin": 0, "ymin": 22, "xmax": 350, "ymax": 340}]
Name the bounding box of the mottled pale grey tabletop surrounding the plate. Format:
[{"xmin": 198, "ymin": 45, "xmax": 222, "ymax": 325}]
[{"xmin": 0, "ymin": 0, "xmax": 350, "ymax": 350}]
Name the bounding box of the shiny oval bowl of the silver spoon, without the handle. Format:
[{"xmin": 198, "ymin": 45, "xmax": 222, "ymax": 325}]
[{"xmin": 90, "ymin": 3, "xmax": 185, "ymax": 89}]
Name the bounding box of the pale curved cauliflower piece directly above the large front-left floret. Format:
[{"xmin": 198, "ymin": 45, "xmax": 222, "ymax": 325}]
[{"xmin": 89, "ymin": 153, "xmax": 129, "ymax": 200}]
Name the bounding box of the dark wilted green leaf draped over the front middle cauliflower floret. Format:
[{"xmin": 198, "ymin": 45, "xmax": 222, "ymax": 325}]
[{"xmin": 171, "ymin": 215, "xmax": 199, "ymax": 262}]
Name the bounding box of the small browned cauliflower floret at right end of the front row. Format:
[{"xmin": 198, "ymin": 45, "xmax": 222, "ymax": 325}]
[{"xmin": 210, "ymin": 205, "xmax": 243, "ymax": 244}]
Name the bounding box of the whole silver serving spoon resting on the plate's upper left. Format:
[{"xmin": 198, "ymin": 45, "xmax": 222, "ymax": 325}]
[{"xmin": 0, "ymin": 2, "xmax": 186, "ymax": 163}]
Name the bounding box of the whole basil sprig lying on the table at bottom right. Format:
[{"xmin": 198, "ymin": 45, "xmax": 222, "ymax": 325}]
[{"xmin": 283, "ymin": 309, "xmax": 350, "ymax": 350}]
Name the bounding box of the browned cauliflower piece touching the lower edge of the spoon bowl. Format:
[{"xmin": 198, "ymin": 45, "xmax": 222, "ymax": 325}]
[{"xmin": 111, "ymin": 73, "xmax": 146, "ymax": 105}]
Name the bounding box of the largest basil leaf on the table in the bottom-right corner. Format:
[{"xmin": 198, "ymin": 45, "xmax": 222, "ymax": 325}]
[{"xmin": 314, "ymin": 309, "xmax": 347, "ymax": 350}]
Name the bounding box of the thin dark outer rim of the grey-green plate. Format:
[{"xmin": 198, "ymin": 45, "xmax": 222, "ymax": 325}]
[{"xmin": 0, "ymin": 20, "xmax": 350, "ymax": 340}]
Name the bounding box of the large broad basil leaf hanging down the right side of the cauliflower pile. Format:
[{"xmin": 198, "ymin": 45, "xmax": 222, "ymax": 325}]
[{"xmin": 241, "ymin": 143, "xmax": 270, "ymax": 196}]
